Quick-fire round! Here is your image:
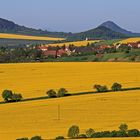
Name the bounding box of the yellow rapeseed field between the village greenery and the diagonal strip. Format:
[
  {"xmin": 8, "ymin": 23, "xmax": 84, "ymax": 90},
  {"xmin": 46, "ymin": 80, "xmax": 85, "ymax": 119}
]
[{"xmin": 0, "ymin": 62, "xmax": 140, "ymax": 99}]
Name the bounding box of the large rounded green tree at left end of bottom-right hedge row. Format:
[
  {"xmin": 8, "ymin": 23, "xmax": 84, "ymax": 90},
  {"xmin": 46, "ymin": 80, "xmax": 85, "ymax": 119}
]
[{"xmin": 68, "ymin": 125, "xmax": 80, "ymax": 138}]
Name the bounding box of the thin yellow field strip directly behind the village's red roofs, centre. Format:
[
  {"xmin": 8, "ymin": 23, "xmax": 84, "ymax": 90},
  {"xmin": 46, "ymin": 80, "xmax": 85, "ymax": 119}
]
[{"xmin": 48, "ymin": 40, "xmax": 100, "ymax": 47}]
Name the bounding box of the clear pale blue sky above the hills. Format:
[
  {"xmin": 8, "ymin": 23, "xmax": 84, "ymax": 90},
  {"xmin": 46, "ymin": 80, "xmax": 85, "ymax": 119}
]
[{"xmin": 0, "ymin": 0, "xmax": 140, "ymax": 32}]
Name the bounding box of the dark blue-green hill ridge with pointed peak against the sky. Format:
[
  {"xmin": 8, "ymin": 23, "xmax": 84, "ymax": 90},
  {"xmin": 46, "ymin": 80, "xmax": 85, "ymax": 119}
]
[{"xmin": 0, "ymin": 18, "xmax": 140, "ymax": 41}]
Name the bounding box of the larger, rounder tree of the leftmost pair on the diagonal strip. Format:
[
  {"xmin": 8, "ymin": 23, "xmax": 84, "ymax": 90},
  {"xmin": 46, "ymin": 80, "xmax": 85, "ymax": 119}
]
[{"xmin": 2, "ymin": 90, "xmax": 13, "ymax": 102}]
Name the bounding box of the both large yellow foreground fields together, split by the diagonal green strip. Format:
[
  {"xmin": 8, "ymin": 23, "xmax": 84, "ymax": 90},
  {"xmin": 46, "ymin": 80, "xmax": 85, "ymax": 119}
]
[{"xmin": 0, "ymin": 63, "xmax": 140, "ymax": 140}]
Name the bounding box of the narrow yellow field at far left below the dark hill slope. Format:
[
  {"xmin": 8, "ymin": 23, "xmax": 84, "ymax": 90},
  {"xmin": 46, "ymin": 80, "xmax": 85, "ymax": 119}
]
[{"xmin": 0, "ymin": 33, "xmax": 64, "ymax": 41}]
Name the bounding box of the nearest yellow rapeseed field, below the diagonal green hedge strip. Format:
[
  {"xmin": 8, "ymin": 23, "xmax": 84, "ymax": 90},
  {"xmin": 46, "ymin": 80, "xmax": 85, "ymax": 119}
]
[{"xmin": 0, "ymin": 91, "xmax": 140, "ymax": 140}]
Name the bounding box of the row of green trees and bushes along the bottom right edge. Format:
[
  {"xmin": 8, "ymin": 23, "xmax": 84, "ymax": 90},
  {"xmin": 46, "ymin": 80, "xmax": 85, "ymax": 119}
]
[{"xmin": 56, "ymin": 124, "xmax": 140, "ymax": 140}]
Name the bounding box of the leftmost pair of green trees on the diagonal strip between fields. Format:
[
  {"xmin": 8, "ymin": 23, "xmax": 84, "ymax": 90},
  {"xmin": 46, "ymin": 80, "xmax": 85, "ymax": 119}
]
[{"xmin": 2, "ymin": 90, "xmax": 23, "ymax": 102}]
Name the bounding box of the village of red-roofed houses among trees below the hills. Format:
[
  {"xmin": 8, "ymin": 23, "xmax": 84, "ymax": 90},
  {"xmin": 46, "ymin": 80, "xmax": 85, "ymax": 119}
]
[{"xmin": 36, "ymin": 39, "xmax": 140, "ymax": 58}]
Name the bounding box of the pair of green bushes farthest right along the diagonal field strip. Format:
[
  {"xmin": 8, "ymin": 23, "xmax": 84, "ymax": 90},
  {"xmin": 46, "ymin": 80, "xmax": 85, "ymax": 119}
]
[{"xmin": 93, "ymin": 83, "xmax": 122, "ymax": 92}]
